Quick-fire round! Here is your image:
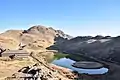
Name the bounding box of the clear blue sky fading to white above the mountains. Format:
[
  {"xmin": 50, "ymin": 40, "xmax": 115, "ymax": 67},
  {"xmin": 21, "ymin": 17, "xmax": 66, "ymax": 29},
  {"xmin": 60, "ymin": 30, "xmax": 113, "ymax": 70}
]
[{"xmin": 0, "ymin": 0, "xmax": 120, "ymax": 36}]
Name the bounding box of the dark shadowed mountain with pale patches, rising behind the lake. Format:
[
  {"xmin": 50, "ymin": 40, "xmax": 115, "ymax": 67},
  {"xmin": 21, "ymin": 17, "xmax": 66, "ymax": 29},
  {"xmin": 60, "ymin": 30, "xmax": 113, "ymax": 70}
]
[{"xmin": 49, "ymin": 35, "xmax": 120, "ymax": 63}]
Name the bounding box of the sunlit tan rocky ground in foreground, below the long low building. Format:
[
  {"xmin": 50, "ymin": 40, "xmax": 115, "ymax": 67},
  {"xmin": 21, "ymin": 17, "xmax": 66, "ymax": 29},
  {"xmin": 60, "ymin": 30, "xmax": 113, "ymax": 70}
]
[{"xmin": 0, "ymin": 57, "xmax": 73, "ymax": 80}]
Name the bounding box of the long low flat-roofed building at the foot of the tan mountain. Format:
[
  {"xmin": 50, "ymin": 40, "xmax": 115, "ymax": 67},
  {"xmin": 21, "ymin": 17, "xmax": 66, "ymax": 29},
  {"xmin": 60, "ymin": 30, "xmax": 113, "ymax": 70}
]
[{"xmin": 1, "ymin": 50, "xmax": 29, "ymax": 58}]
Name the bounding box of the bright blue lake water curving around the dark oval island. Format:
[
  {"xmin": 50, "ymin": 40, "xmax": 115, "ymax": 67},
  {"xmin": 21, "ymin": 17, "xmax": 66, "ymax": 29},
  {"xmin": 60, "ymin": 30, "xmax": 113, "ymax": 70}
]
[{"xmin": 52, "ymin": 57, "xmax": 108, "ymax": 74}]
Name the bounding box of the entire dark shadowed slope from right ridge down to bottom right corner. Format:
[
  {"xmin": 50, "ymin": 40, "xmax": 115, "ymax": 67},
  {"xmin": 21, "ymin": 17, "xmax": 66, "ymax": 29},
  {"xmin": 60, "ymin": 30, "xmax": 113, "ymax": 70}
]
[{"xmin": 49, "ymin": 36, "xmax": 120, "ymax": 80}]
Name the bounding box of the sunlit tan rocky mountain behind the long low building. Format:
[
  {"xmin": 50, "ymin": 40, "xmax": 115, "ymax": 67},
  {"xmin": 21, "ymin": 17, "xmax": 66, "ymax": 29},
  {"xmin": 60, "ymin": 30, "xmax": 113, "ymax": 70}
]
[{"xmin": 0, "ymin": 25, "xmax": 71, "ymax": 50}]
